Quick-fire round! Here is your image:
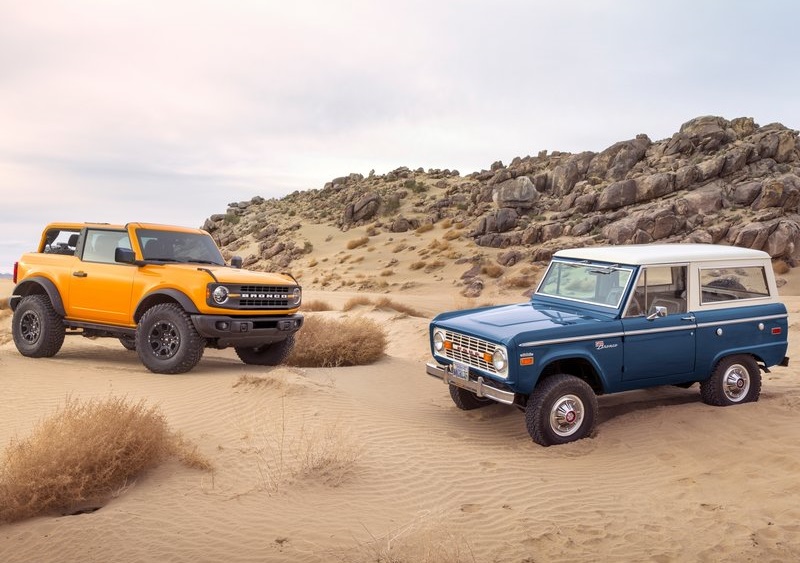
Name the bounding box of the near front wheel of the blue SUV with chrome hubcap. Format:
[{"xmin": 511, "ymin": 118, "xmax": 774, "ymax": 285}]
[{"xmin": 525, "ymin": 374, "xmax": 597, "ymax": 446}]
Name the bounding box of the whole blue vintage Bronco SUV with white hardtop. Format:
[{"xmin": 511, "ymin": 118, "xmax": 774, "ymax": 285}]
[{"xmin": 426, "ymin": 244, "xmax": 789, "ymax": 446}]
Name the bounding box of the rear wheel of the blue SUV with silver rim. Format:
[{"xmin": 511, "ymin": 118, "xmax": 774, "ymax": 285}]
[{"xmin": 700, "ymin": 354, "xmax": 761, "ymax": 407}]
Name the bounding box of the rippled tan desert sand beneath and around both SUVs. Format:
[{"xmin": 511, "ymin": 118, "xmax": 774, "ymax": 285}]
[{"xmin": 0, "ymin": 233, "xmax": 800, "ymax": 563}]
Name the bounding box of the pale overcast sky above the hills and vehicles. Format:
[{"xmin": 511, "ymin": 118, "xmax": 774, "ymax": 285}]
[{"xmin": 0, "ymin": 0, "xmax": 800, "ymax": 273}]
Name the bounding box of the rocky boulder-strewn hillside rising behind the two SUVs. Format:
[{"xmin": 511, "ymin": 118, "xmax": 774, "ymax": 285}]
[{"xmin": 203, "ymin": 116, "xmax": 800, "ymax": 296}]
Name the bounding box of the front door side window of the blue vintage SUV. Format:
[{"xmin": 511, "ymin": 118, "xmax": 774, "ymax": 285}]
[{"xmin": 625, "ymin": 266, "xmax": 686, "ymax": 317}]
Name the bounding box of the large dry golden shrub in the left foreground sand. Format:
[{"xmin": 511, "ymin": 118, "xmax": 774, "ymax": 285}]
[{"xmin": 0, "ymin": 398, "xmax": 210, "ymax": 522}]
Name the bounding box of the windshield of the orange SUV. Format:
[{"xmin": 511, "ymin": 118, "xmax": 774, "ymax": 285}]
[{"xmin": 136, "ymin": 229, "xmax": 225, "ymax": 266}]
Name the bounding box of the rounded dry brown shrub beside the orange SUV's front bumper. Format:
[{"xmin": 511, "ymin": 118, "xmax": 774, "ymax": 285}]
[{"xmin": 286, "ymin": 316, "xmax": 387, "ymax": 367}]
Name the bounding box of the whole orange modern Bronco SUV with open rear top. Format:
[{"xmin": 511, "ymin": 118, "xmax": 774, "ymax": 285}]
[{"xmin": 11, "ymin": 223, "xmax": 303, "ymax": 373}]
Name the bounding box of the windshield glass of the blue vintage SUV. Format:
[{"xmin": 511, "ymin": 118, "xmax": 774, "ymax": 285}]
[{"xmin": 536, "ymin": 260, "xmax": 633, "ymax": 308}]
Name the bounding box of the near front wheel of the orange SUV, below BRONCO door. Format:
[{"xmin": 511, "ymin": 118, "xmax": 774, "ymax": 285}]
[{"xmin": 136, "ymin": 303, "xmax": 206, "ymax": 373}]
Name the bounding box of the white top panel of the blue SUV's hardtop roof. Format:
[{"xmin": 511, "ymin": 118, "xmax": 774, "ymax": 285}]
[{"xmin": 553, "ymin": 243, "xmax": 769, "ymax": 266}]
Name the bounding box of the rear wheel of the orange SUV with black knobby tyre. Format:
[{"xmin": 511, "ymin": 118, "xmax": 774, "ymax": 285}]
[{"xmin": 11, "ymin": 295, "xmax": 66, "ymax": 358}]
